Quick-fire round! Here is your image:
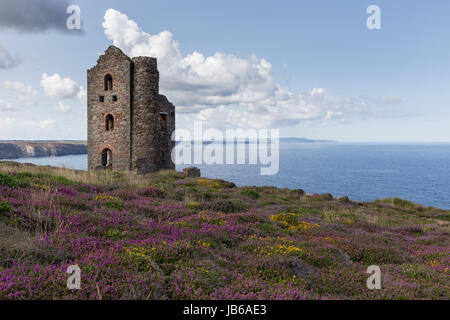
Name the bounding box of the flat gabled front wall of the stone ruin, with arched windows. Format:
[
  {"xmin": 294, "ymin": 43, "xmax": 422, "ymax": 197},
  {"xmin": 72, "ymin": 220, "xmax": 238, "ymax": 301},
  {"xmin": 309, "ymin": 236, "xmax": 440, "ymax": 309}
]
[{"xmin": 88, "ymin": 46, "xmax": 132, "ymax": 171}]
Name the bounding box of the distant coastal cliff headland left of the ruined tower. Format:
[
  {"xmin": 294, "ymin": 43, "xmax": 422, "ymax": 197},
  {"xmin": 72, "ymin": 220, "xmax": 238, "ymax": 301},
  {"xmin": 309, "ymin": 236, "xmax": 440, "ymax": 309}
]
[{"xmin": 0, "ymin": 142, "xmax": 87, "ymax": 159}]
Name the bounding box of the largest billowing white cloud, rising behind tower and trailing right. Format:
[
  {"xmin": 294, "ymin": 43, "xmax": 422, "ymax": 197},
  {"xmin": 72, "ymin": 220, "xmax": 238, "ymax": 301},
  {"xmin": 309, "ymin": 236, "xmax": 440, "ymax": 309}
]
[{"xmin": 103, "ymin": 9, "xmax": 380, "ymax": 127}]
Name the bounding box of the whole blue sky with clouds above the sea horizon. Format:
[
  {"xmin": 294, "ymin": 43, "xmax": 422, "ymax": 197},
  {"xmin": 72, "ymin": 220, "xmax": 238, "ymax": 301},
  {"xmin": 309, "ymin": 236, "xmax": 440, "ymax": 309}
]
[{"xmin": 0, "ymin": 0, "xmax": 450, "ymax": 142}]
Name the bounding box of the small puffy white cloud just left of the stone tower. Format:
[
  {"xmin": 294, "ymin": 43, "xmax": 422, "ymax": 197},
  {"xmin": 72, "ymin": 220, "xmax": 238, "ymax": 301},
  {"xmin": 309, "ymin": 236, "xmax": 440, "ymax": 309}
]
[{"xmin": 41, "ymin": 73, "xmax": 85, "ymax": 100}]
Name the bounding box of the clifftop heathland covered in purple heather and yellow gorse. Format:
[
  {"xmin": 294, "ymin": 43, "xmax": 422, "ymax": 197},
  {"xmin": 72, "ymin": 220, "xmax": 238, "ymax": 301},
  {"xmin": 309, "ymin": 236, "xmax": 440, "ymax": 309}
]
[{"xmin": 0, "ymin": 163, "xmax": 450, "ymax": 299}]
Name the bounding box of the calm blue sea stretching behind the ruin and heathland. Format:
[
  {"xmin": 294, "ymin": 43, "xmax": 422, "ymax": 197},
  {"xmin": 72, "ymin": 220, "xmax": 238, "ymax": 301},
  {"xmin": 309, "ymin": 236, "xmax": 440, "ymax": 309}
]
[{"xmin": 6, "ymin": 142, "xmax": 450, "ymax": 209}]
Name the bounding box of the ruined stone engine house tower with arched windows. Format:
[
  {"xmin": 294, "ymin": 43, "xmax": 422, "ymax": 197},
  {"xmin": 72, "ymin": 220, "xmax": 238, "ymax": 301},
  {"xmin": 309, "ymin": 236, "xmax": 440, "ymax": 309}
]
[{"xmin": 87, "ymin": 46, "xmax": 175, "ymax": 174}]
